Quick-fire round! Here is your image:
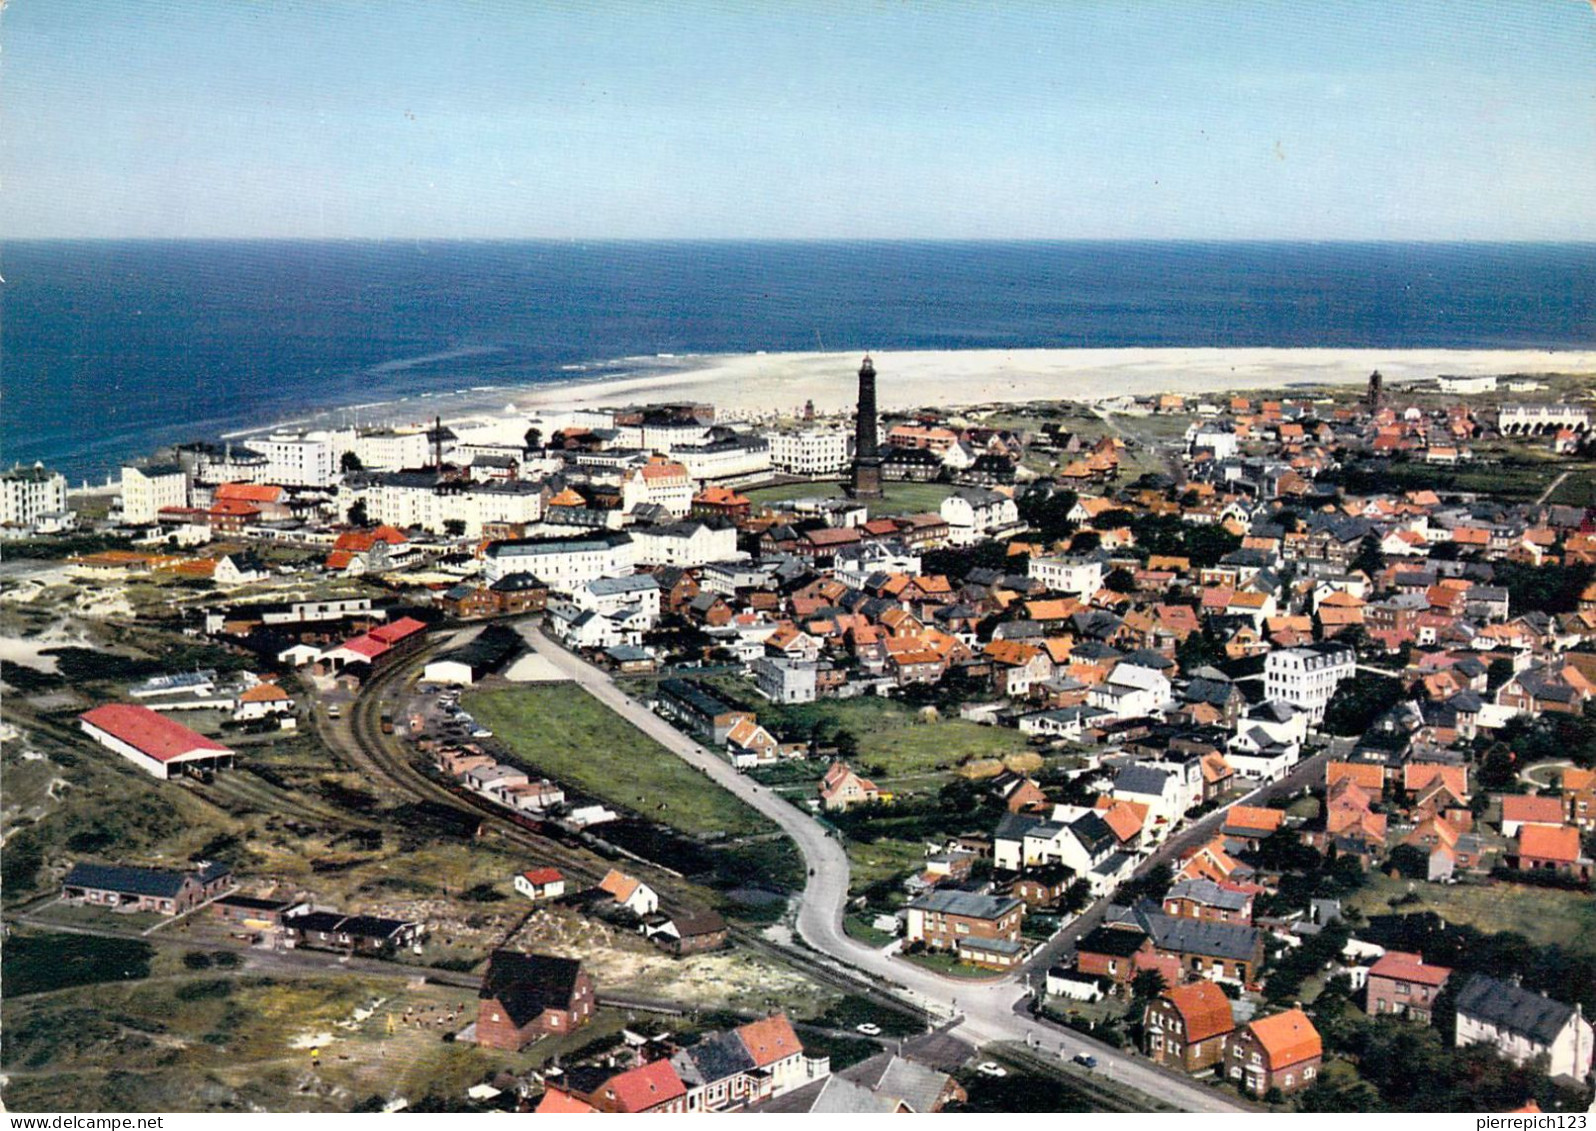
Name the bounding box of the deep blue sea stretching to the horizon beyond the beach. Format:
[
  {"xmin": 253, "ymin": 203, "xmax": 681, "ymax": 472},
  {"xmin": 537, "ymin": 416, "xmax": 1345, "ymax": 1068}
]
[{"xmin": 0, "ymin": 241, "xmax": 1596, "ymax": 482}]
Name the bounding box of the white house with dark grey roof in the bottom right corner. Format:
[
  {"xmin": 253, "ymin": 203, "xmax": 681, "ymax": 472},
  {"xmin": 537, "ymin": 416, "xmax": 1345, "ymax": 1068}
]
[{"xmin": 1457, "ymin": 975, "xmax": 1596, "ymax": 1085}]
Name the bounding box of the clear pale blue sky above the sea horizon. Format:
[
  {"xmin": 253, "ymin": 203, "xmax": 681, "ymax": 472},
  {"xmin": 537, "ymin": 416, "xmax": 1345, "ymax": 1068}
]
[{"xmin": 0, "ymin": 0, "xmax": 1596, "ymax": 239}]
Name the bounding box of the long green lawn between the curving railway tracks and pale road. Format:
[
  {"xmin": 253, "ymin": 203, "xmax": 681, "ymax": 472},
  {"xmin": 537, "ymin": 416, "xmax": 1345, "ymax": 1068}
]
[{"xmin": 466, "ymin": 683, "xmax": 776, "ymax": 836}]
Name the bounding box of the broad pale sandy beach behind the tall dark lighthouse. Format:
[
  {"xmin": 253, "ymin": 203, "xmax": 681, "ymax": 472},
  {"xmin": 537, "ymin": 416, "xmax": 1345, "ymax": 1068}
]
[{"xmin": 516, "ymin": 349, "xmax": 1596, "ymax": 416}]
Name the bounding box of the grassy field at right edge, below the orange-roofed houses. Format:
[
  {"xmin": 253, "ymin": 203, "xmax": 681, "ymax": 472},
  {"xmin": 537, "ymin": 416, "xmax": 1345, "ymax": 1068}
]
[{"xmin": 1352, "ymin": 874, "xmax": 1596, "ymax": 954}]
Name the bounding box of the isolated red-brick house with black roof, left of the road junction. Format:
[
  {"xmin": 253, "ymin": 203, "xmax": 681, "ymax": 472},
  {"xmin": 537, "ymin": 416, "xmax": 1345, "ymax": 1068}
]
[{"xmin": 477, "ymin": 951, "xmax": 597, "ymax": 1051}]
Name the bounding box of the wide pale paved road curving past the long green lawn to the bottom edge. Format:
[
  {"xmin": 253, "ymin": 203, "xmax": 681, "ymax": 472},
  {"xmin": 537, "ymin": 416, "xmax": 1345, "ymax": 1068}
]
[{"xmin": 525, "ymin": 629, "xmax": 1248, "ymax": 1112}]
